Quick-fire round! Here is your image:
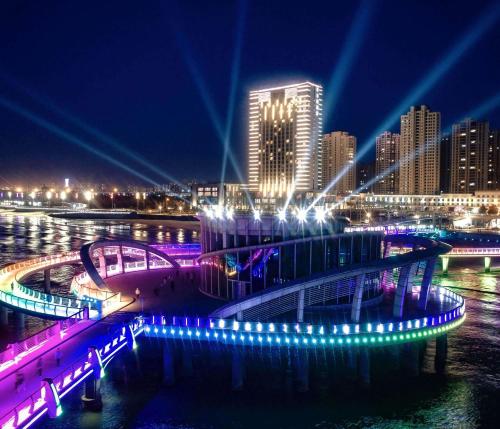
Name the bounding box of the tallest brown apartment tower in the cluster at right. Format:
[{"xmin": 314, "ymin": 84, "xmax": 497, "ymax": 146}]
[{"xmin": 399, "ymin": 105, "xmax": 441, "ymax": 195}]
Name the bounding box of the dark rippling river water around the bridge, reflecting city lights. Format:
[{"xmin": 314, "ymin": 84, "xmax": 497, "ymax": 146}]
[{"xmin": 0, "ymin": 214, "xmax": 500, "ymax": 429}]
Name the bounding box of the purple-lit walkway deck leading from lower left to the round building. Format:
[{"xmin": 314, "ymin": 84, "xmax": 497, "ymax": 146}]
[{"xmin": 0, "ymin": 268, "xmax": 220, "ymax": 424}]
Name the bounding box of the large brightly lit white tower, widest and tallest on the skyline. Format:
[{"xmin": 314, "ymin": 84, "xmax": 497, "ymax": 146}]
[{"xmin": 248, "ymin": 82, "xmax": 323, "ymax": 197}]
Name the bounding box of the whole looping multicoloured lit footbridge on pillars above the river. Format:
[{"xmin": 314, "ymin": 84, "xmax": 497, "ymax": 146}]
[{"xmin": 0, "ymin": 235, "xmax": 465, "ymax": 429}]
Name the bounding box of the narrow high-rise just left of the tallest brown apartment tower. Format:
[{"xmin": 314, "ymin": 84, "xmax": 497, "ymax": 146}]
[{"xmin": 375, "ymin": 131, "xmax": 400, "ymax": 194}]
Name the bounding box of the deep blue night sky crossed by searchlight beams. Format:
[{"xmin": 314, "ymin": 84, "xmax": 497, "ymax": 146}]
[{"xmin": 0, "ymin": 0, "xmax": 500, "ymax": 186}]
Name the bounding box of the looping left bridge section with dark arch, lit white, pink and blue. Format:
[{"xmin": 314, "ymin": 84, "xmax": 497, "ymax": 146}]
[{"xmin": 0, "ymin": 240, "xmax": 199, "ymax": 319}]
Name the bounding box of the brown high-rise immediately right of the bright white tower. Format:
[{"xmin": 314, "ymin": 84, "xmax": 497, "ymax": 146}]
[{"xmin": 322, "ymin": 131, "xmax": 356, "ymax": 195}]
